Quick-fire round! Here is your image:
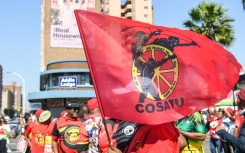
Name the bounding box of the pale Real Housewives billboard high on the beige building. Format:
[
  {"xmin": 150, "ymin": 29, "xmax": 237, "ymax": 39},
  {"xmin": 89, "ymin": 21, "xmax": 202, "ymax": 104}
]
[{"xmin": 50, "ymin": 0, "xmax": 95, "ymax": 48}]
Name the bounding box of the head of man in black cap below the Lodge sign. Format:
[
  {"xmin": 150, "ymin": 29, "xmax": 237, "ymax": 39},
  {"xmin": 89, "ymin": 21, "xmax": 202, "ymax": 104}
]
[{"xmin": 66, "ymin": 100, "xmax": 80, "ymax": 118}]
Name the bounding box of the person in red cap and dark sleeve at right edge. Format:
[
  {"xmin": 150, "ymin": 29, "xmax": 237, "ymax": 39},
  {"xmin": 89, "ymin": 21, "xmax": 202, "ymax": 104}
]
[{"xmin": 216, "ymin": 88, "xmax": 245, "ymax": 153}]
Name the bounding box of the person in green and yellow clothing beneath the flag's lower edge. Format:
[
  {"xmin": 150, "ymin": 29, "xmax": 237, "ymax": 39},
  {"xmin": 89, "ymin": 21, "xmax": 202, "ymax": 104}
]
[{"xmin": 177, "ymin": 112, "xmax": 206, "ymax": 153}]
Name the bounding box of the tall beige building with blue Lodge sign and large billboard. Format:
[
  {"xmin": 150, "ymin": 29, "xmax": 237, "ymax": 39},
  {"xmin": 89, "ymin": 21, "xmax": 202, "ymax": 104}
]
[{"xmin": 28, "ymin": 0, "xmax": 152, "ymax": 116}]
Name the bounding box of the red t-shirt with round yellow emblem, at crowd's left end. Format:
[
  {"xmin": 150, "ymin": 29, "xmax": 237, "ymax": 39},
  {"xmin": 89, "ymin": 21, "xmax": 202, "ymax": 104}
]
[{"xmin": 25, "ymin": 123, "xmax": 48, "ymax": 153}]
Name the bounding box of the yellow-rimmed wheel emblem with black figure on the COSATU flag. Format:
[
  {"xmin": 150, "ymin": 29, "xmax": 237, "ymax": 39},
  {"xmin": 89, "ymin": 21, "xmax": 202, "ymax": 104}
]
[{"xmin": 132, "ymin": 44, "xmax": 178, "ymax": 102}]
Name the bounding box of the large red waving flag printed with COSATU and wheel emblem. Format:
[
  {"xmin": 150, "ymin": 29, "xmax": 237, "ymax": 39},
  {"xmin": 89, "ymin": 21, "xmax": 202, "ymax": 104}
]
[{"xmin": 75, "ymin": 10, "xmax": 241, "ymax": 124}]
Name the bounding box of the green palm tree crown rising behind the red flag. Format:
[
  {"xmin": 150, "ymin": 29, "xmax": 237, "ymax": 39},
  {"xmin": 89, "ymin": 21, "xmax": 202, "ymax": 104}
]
[{"xmin": 183, "ymin": 1, "xmax": 234, "ymax": 47}]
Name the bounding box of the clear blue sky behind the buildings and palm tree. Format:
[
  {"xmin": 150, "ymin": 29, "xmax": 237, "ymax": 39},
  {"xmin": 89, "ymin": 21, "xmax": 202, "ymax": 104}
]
[{"xmin": 0, "ymin": 0, "xmax": 245, "ymax": 103}]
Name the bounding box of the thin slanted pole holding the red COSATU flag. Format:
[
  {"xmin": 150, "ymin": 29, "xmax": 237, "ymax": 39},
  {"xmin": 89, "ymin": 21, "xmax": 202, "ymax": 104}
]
[{"xmin": 74, "ymin": 10, "xmax": 111, "ymax": 146}]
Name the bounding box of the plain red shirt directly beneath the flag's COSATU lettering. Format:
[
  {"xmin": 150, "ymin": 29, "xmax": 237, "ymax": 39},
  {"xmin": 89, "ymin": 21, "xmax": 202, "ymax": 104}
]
[{"xmin": 127, "ymin": 122, "xmax": 180, "ymax": 153}]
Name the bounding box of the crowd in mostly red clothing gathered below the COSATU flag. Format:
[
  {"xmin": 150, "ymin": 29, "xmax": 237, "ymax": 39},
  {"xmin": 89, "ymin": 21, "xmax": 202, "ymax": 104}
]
[{"xmin": 12, "ymin": 88, "xmax": 245, "ymax": 153}]
